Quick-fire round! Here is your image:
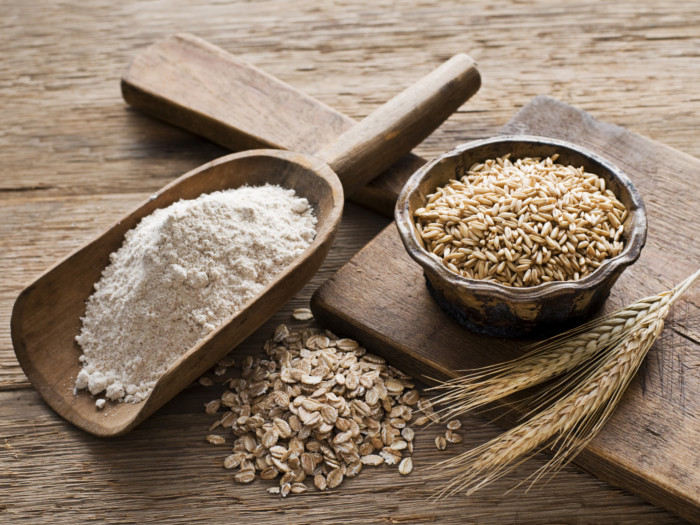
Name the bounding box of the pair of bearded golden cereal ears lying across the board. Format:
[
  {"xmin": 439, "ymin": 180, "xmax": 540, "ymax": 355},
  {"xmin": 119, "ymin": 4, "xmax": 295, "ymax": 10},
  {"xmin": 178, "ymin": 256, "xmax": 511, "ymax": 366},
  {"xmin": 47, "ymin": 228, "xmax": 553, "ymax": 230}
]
[{"xmin": 432, "ymin": 270, "xmax": 700, "ymax": 498}]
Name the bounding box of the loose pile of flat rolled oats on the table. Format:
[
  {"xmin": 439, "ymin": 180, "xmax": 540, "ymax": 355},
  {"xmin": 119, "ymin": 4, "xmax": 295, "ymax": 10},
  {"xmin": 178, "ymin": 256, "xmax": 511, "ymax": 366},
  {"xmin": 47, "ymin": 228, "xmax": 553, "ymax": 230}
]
[{"xmin": 205, "ymin": 312, "xmax": 439, "ymax": 497}]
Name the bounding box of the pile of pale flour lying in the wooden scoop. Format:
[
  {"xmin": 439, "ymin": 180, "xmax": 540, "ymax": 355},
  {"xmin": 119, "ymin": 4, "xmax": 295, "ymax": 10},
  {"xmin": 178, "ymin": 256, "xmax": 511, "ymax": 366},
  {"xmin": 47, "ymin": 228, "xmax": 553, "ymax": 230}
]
[{"xmin": 75, "ymin": 185, "xmax": 316, "ymax": 403}]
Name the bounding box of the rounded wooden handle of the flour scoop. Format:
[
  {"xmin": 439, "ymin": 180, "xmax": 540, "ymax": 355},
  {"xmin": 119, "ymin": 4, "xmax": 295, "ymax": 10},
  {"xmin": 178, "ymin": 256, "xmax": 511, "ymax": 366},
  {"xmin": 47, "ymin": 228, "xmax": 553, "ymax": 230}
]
[{"xmin": 314, "ymin": 53, "xmax": 481, "ymax": 195}]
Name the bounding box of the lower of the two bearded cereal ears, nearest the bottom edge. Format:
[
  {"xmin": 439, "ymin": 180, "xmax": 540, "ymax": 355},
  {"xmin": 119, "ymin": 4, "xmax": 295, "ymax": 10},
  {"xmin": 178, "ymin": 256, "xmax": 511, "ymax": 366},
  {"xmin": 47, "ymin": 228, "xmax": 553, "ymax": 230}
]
[{"xmin": 431, "ymin": 270, "xmax": 700, "ymax": 498}]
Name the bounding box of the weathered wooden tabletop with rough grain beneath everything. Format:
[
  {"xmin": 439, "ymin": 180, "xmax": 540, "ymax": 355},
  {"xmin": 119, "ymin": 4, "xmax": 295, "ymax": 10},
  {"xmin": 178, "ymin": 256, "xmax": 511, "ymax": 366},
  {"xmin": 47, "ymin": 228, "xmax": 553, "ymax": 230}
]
[{"xmin": 0, "ymin": 0, "xmax": 700, "ymax": 523}]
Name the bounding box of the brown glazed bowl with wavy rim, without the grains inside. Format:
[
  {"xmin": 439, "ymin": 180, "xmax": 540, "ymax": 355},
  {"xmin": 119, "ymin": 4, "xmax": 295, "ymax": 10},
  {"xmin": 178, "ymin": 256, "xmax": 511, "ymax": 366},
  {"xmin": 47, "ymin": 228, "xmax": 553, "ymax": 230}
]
[{"xmin": 394, "ymin": 135, "xmax": 647, "ymax": 337}]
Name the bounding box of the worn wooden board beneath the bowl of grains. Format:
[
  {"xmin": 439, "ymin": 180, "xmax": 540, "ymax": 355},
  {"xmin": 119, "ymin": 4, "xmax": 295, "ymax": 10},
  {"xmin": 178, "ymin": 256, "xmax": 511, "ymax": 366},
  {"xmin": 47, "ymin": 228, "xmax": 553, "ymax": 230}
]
[{"xmin": 312, "ymin": 97, "xmax": 700, "ymax": 521}]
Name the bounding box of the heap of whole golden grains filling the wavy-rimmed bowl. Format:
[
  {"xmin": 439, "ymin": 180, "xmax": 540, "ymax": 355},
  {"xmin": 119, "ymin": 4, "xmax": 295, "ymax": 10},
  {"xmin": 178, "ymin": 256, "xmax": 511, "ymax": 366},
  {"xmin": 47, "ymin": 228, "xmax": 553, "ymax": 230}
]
[{"xmin": 415, "ymin": 155, "xmax": 627, "ymax": 287}]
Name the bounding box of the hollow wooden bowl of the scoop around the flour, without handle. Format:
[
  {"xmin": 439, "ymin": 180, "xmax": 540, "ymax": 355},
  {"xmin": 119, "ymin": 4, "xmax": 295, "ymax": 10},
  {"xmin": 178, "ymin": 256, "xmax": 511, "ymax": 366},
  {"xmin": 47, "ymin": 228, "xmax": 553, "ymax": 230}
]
[{"xmin": 11, "ymin": 150, "xmax": 343, "ymax": 437}]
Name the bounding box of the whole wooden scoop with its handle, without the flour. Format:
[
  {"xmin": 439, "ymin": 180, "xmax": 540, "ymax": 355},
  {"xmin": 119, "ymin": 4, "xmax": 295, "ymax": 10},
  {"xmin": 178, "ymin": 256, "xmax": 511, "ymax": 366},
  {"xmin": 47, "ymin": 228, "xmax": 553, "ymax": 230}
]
[{"xmin": 11, "ymin": 55, "xmax": 478, "ymax": 436}]
